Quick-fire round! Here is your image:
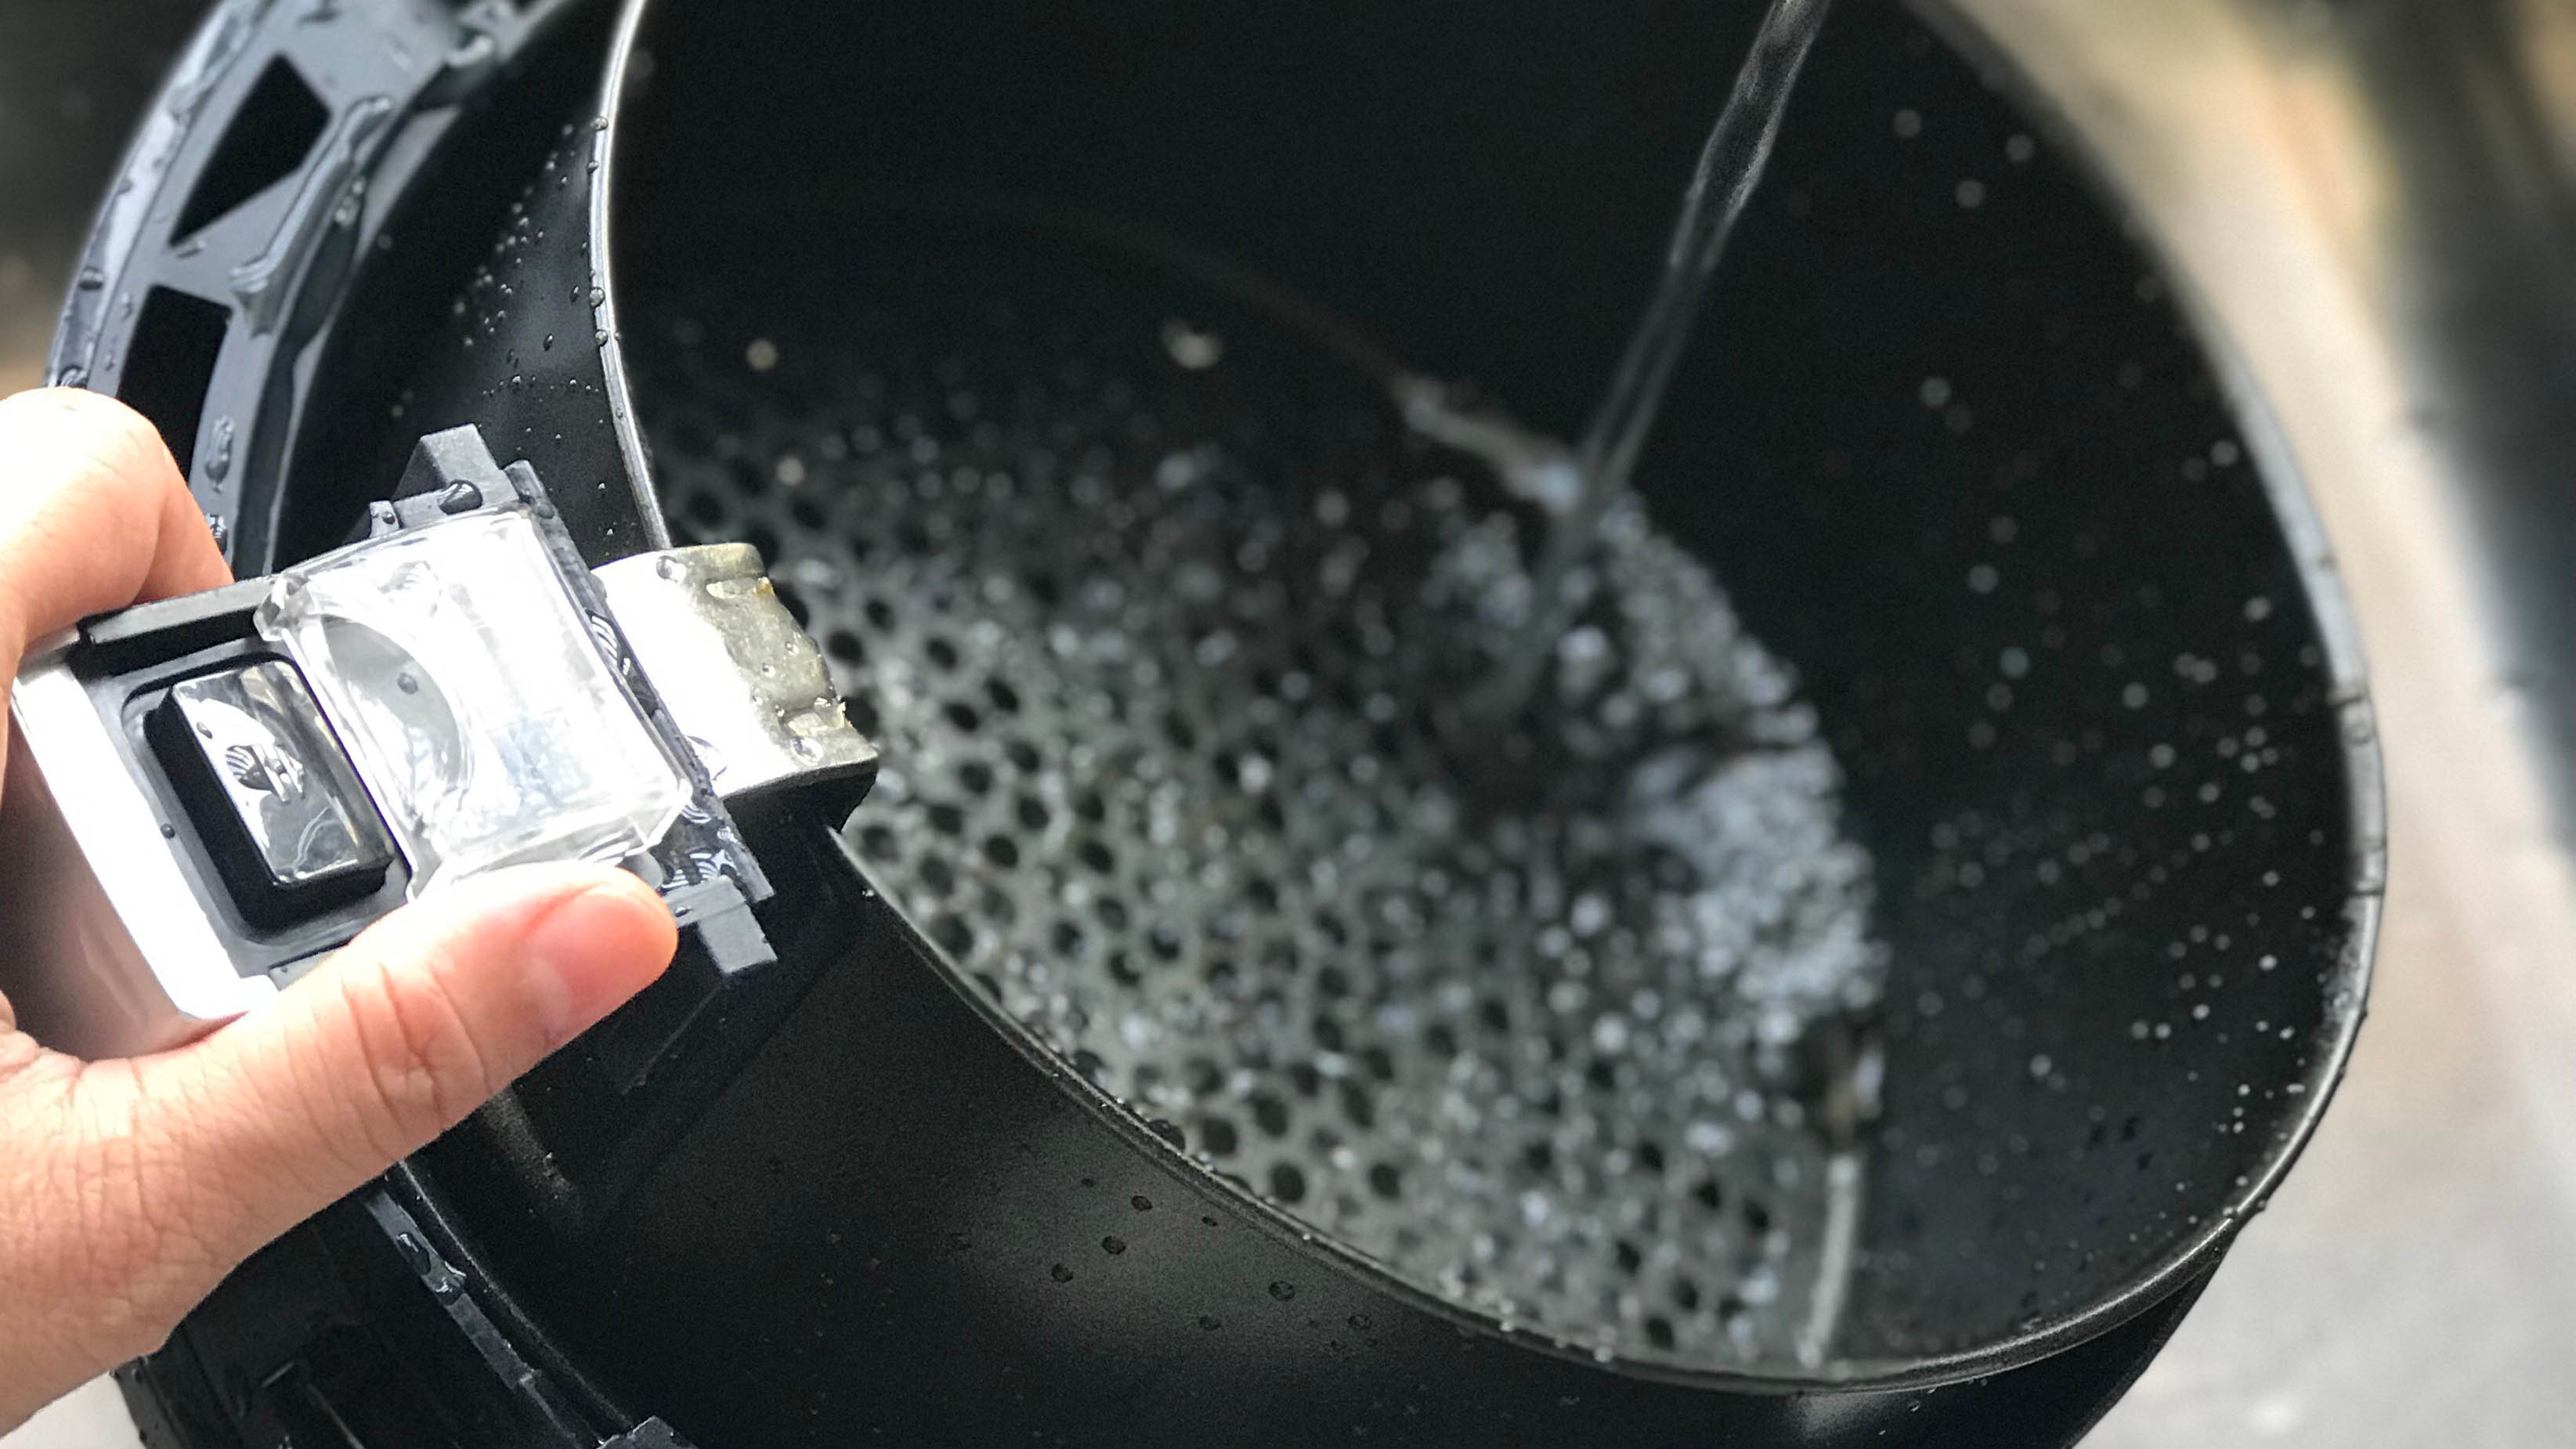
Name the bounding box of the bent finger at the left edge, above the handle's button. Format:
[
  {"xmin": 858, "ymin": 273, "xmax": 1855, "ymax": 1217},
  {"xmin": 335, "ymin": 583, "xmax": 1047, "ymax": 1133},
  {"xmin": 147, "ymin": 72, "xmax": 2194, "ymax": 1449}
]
[{"xmin": 0, "ymin": 387, "xmax": 232, "ymax": 657}]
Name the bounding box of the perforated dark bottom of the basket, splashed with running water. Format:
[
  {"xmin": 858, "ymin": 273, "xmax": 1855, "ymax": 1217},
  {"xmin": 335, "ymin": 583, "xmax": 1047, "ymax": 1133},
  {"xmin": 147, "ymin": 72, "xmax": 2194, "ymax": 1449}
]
[{"xmin": 631, "ymin": 244, "xmax": 1881, "ymax": 1367}]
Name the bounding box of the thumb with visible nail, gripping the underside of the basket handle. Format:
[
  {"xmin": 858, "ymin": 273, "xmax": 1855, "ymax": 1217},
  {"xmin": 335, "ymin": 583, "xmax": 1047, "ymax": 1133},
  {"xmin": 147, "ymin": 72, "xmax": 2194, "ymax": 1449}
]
[{"xmin": 136, "ymin": 866, "xmax": 677, "ymax": 1266}]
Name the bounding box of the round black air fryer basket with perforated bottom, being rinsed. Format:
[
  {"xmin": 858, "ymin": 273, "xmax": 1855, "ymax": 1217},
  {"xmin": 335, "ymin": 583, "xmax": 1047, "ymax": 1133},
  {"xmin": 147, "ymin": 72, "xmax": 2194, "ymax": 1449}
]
[{"xmin": 65, "ymin": 0, "xmax": 2380, "ymax": 1447}]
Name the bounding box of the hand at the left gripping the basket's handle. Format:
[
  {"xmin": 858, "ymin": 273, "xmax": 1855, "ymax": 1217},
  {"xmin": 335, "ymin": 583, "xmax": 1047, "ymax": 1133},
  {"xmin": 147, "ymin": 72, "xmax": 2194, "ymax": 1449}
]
[{"xmin": 0, "ymin": 389, "xmax": 677, "ymax": 1433}]
